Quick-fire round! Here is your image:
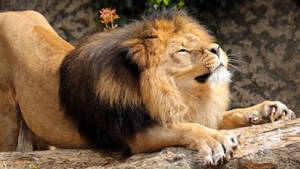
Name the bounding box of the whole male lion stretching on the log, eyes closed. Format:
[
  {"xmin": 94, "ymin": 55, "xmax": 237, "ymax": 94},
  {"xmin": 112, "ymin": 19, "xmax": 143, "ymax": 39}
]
[{"xmin": 0, "ymin": 11, "xmax": 295, "ymax": 165}]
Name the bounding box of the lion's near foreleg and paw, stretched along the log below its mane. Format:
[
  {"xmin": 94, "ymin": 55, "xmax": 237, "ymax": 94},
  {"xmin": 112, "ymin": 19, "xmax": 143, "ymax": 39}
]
[{"xmin": 128, "ymin": 123, "xmax": 238, "ymax": 164}]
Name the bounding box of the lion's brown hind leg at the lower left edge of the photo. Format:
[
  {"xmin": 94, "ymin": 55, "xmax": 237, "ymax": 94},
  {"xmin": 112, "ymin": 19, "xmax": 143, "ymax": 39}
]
[{"xmin": 0, "ymin": 88, "xmax": 19, "ymax": 151}]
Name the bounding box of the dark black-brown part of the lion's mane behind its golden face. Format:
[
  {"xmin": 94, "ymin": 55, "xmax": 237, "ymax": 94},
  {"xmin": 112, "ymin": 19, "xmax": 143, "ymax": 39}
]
[{"xmin": 59, "ymin": 11, "xmax": 214, "ymax": 152}]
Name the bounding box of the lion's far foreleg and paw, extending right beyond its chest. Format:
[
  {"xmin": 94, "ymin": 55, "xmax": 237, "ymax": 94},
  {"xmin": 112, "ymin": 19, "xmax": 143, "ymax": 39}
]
[{"xmin": 219, "ymin": 101, "xmax": 295, "ymax": 129}]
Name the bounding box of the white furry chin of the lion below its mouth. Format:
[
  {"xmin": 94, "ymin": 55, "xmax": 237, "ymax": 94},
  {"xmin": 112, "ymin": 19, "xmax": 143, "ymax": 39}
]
[{"xmin": 207, "ymin": 66, "xmax": 231, "ymax": 85}]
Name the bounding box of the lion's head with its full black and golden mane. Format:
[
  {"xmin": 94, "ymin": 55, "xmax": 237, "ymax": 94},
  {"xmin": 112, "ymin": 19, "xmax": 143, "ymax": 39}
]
[{"xmin": 59, "ymin": 11, "xmax": 230, "ymax": 153}]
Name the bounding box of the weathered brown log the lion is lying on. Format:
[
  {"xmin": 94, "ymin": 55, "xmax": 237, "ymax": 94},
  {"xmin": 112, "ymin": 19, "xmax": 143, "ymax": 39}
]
[{"xmin": 0, "ymin": 118, "xmax": 300, "ymax": 169}]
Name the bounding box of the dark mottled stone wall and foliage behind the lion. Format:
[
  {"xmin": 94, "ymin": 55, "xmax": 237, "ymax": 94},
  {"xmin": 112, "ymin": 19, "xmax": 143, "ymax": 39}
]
[{"xmin": 0, "ymin": 0, "xmax": 300, "ymax": 117}]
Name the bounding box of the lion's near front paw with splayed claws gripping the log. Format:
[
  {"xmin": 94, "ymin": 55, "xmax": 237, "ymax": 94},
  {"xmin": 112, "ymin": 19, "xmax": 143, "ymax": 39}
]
[{"xmin": 188, "ymin": 131, "xmax": 240, "ymax": 165}]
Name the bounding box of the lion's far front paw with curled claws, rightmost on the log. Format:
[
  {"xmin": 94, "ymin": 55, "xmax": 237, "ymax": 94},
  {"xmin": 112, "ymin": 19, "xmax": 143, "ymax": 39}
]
[{"xmin": 260, "ymin": 101, "xmax": 296, "ymax": 122}]
